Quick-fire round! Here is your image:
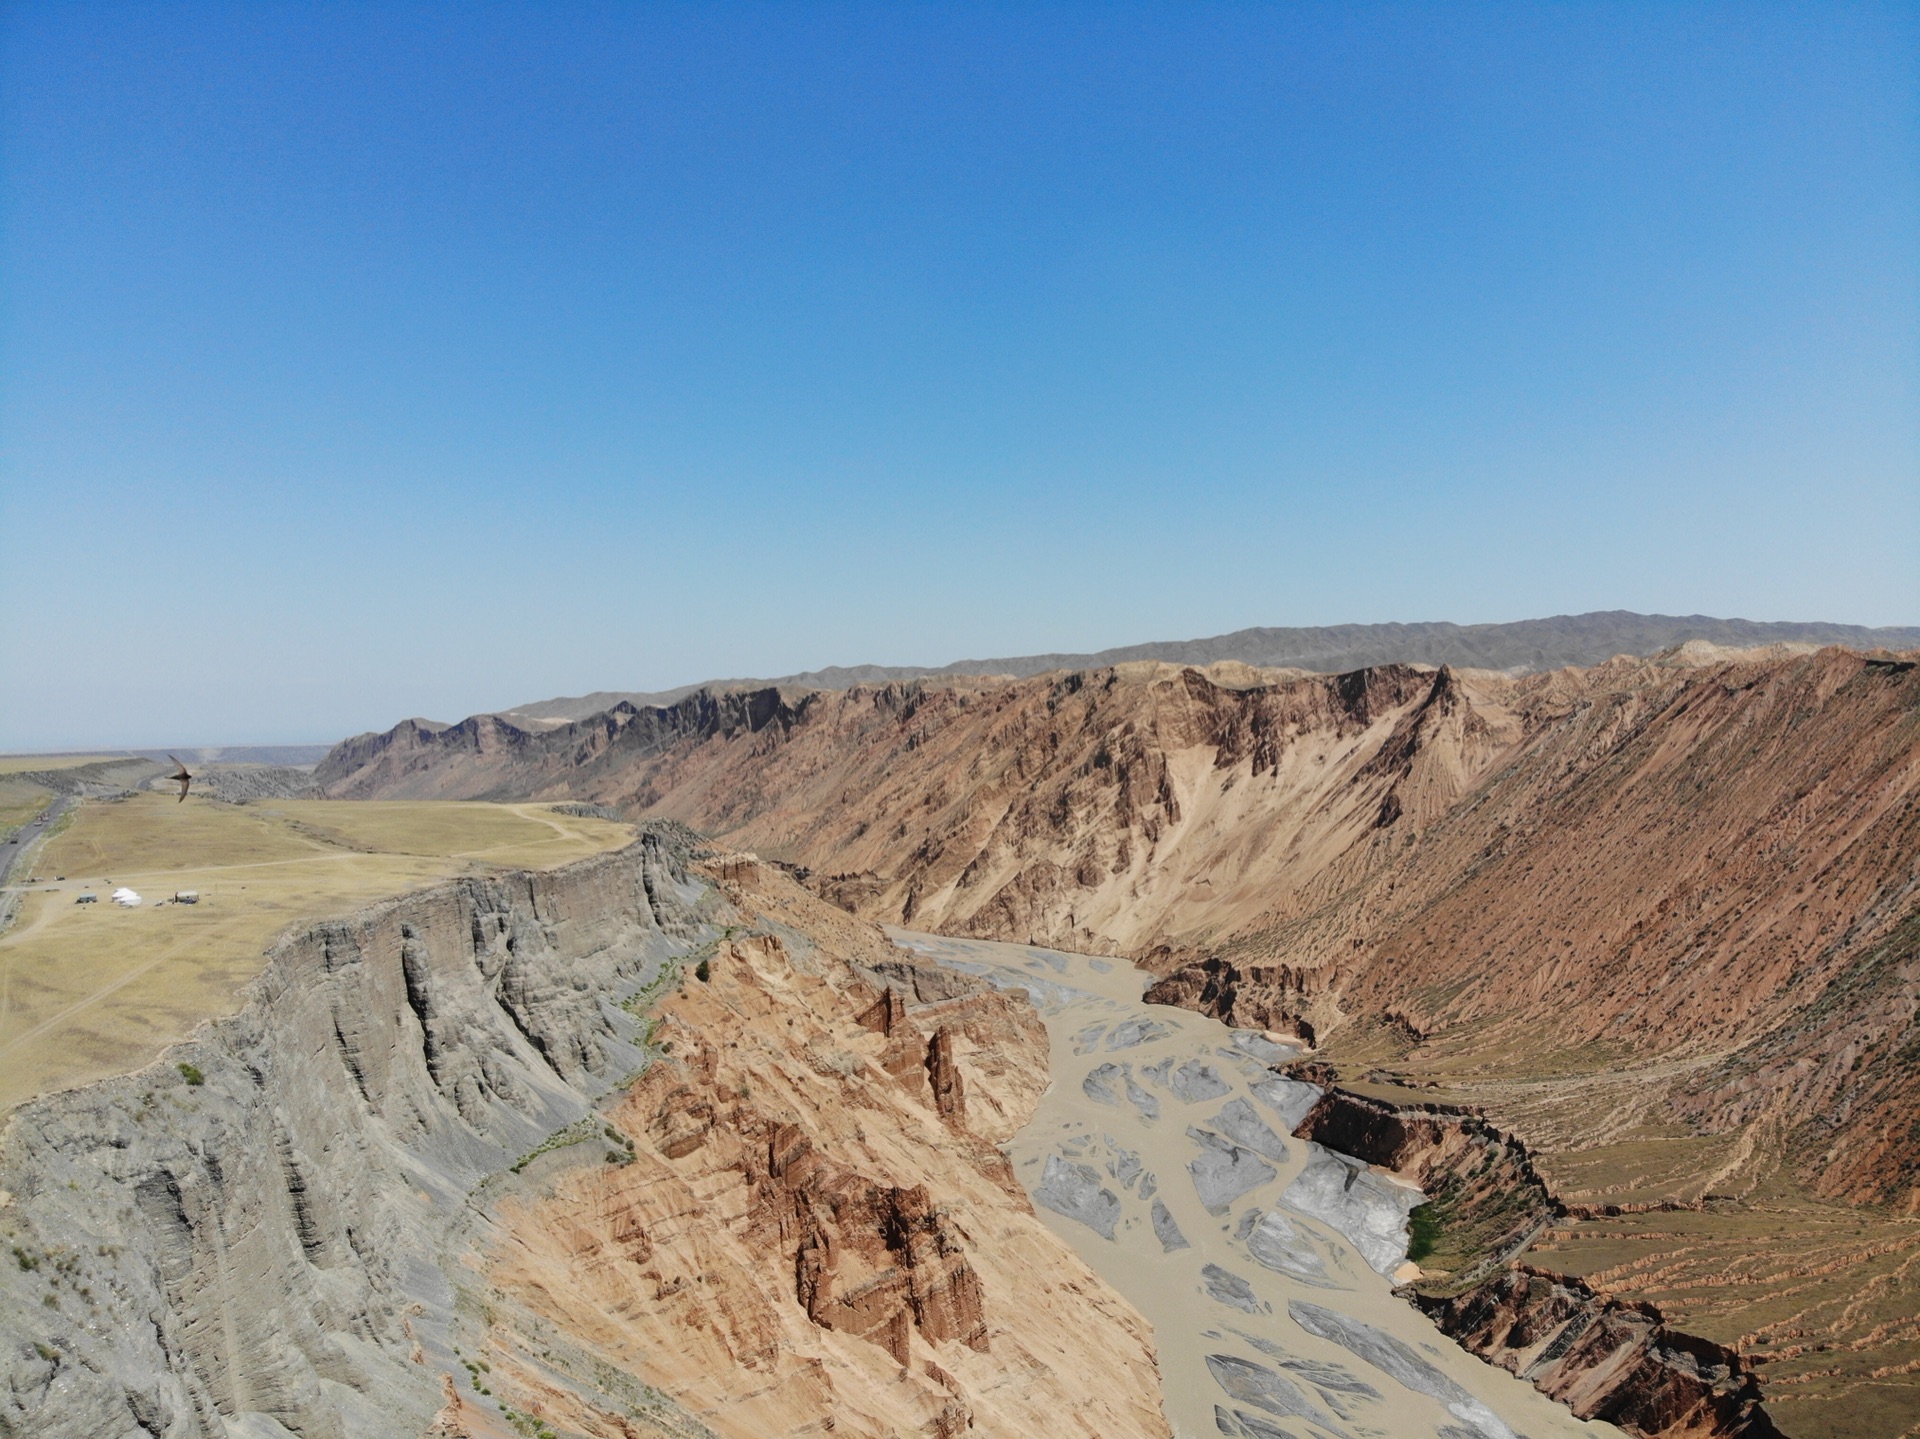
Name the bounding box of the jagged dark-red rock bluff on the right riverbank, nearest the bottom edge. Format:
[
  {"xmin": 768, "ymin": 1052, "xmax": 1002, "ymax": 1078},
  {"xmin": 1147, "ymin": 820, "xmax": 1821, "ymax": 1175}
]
[{"xmin": 1415, "ymin": 1264, "xmax": 1780, "ymax": 1439}]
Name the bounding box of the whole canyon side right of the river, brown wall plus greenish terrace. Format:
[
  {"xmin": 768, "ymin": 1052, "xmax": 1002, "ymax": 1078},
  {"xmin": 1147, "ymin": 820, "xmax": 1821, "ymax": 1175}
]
[{"xmin": 317, "ymin": 646, "xmax": 1920, "ymax": 1439}]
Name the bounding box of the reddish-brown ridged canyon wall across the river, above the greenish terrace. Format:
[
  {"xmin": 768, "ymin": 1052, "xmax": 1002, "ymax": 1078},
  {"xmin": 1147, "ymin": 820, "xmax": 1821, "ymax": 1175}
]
[{"xmin": 319, "ymin": 649, "xmax": 1920, "ymax": 1207}]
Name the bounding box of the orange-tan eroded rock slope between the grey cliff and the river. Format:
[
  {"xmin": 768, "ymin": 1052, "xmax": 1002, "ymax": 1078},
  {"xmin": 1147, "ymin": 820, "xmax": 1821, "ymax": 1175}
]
[{"xmin": 478, "ymin": 861, "xmax": 1165, "ymax": 1435}]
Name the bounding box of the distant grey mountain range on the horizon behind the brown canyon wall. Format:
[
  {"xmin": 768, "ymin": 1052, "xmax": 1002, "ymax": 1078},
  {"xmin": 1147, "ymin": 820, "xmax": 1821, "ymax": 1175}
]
[{"xmin": 499, "ymin": 609, "xmax": 1920, "ymax": 720}]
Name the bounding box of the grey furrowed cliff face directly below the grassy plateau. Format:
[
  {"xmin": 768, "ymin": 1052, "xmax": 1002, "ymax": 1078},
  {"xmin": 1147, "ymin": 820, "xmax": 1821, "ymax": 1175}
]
[{"xmin": 0, "ymin": 834, "xmax": 699, "ymax": 1439}]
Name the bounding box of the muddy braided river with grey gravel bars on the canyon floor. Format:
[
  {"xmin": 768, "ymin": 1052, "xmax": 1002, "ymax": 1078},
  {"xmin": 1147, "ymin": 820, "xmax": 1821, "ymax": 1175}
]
[{"xmin": 895, "ymin": 932, "xmax": 1620, "ymax": 1439}]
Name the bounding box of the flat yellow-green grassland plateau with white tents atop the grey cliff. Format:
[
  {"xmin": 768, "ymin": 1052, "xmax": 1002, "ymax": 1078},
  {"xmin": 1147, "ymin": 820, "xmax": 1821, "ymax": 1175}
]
[{"xmin": 0, "ymin": 793, "xmax": 634, "ymax": 1112}]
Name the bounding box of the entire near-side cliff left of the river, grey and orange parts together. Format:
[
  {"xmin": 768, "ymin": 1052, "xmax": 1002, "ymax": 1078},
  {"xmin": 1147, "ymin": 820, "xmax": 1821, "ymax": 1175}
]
[{"xmin": 0, "ymin": 834, "xmax": 1164, "ymax": 1439}]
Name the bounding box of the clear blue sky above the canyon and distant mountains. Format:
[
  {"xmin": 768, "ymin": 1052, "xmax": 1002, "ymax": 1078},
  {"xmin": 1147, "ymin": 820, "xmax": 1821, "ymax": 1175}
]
[{"xmin": 0, "ymin": 2, "xmax": 1920, "ymax": 749}]
